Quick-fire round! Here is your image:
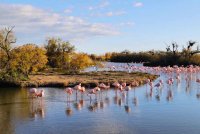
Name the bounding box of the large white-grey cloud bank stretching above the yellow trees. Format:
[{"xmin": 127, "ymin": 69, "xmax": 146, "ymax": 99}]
[{"xmin": 0, "ymin": 4, "xmax": 119, "ymax": 43}]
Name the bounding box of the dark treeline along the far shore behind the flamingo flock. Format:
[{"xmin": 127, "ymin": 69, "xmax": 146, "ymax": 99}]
[{"xmin": 91, "ymin": 41, "xmax": 200, "ymax": 66}]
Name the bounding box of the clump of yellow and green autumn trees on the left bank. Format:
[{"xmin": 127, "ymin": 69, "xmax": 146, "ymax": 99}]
[{"xmin": 0, "ymin": 27, "xmax": 94, "ymax": 81}]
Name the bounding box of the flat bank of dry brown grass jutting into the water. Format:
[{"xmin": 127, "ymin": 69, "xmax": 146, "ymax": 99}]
[{"xmin": 0, "ymin": 72, "xmax": 158, "ymax": 87}]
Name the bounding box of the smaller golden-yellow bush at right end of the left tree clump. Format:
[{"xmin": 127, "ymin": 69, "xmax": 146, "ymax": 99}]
[{"xmin": 71, "ymin": 53, "xmax": 94, "ymax": 71}]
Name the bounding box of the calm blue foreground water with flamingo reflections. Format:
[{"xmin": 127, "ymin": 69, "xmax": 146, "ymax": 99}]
[{"xmin": 0, "ymin": 67, "xmax": 200, "ymax": 134}]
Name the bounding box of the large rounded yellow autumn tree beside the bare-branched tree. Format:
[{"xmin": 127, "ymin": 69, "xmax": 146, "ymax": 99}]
[{"xmin": 11, "ymin": 44, "xmax": 47, "ymax": 76}]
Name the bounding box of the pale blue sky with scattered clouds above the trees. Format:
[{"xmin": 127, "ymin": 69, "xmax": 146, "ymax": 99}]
[{"xmin": 0, "ymin": 0, "xmax": 200, "ymax": 54}]
